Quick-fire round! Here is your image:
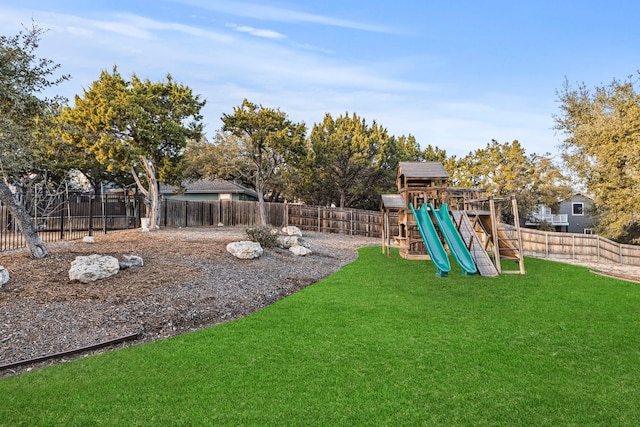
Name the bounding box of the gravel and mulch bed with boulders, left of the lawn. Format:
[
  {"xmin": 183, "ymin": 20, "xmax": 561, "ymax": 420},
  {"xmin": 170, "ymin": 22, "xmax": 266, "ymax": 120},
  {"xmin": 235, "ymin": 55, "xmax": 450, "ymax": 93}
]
[{"xmin": 0, "ymin": 227, "xmax": 379, "ymax": 377}]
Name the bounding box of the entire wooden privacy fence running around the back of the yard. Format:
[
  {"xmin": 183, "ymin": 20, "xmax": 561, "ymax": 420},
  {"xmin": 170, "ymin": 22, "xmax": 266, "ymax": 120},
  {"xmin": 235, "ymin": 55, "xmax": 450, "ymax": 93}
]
[{"xmin": 0, "ymin": 195, "xmax": 640, "ymax": 265}]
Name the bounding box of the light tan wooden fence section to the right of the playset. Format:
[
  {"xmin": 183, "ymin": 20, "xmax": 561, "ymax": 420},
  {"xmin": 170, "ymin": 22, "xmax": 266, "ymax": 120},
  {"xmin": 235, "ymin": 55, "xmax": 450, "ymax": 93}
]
[{"xmin": 522, "ymin": 229, "xmax": 640, "ymax": 265}]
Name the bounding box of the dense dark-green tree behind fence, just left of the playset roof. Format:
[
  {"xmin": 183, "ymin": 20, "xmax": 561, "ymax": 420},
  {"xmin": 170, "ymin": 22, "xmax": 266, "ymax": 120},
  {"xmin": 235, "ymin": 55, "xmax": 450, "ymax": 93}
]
[{"xmin": 292, "ymin": 113, "xmax": 446, "ymax": 209}]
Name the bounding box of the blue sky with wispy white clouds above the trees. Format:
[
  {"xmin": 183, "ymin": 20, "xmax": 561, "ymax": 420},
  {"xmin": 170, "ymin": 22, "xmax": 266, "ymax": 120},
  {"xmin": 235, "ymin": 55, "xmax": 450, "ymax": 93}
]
[{"xmin": 0, "ymin": 0, "xmax": 640, "ymax": 156}]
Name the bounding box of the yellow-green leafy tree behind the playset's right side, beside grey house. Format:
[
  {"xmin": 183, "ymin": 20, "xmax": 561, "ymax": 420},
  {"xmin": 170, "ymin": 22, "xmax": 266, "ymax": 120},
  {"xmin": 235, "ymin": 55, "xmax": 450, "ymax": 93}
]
[{"xmin": 447, "ymin": 140, "xmax": 571, "ymax": 222}]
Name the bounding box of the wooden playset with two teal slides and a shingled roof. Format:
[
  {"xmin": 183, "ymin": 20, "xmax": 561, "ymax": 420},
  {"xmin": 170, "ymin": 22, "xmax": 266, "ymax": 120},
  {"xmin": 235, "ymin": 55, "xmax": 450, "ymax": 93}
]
[{"xmin": 381, "ymin": 162, "xmax": 525, "ymax": 277}]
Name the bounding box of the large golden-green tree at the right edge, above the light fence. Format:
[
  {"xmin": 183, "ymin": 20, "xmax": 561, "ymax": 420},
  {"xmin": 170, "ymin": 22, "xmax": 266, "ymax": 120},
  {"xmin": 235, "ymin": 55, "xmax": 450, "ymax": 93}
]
[{"xmin": 554, "ymin": 77, "xmax": 640, "ymax": 242}]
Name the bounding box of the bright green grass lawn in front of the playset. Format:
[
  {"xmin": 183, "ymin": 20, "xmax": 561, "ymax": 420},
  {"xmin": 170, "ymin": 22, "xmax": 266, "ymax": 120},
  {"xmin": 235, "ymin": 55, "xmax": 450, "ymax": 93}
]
[{"xmin": 0, "ymin": 248, "xmax": 640, "ymax": 426}]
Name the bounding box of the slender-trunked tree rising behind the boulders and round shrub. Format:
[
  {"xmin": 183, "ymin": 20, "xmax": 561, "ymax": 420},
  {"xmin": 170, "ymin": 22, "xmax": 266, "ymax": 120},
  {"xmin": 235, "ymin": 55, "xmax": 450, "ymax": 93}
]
[{"xmin": 222, "ymin": 99, "xmax": 306, "ymax": 225}]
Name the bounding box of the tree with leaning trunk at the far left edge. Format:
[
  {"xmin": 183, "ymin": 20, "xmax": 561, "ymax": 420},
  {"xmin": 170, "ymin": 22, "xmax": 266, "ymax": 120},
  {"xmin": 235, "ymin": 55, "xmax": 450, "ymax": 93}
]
[{"xmin": 0, "ymin": 25, "xmax": 69, "ymax": 258}]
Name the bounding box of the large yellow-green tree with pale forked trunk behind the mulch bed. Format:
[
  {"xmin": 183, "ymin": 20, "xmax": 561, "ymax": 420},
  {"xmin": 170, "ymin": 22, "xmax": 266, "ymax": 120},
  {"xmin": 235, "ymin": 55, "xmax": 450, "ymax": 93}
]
[{"xmin": 63, "ymin": 67, "xmax": 205, "ymax": 228}]
